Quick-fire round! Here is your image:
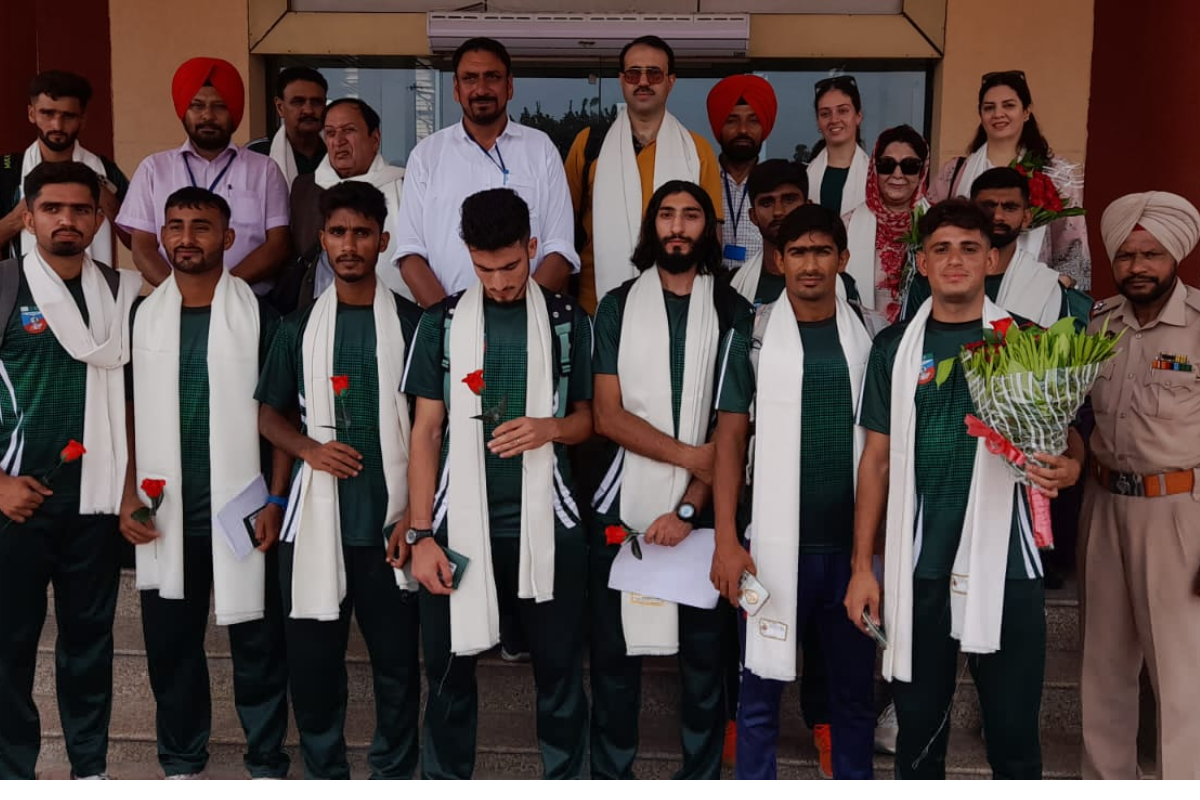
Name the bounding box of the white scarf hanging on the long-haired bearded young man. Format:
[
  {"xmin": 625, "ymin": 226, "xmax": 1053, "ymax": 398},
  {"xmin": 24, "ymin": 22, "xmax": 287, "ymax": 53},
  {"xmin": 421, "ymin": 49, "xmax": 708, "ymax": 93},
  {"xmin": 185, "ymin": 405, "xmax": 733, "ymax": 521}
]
[{"xmin": 617, "ymin": 267, "xmax": 720, "ymax": 656}]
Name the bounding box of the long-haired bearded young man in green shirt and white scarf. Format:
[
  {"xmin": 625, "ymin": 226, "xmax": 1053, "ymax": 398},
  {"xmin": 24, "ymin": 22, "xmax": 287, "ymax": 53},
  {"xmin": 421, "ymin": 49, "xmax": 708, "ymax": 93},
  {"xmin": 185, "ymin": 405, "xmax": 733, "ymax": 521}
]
[{"xmin": 589, "ymin": 181, "xmax": 751, "ymax": 778}]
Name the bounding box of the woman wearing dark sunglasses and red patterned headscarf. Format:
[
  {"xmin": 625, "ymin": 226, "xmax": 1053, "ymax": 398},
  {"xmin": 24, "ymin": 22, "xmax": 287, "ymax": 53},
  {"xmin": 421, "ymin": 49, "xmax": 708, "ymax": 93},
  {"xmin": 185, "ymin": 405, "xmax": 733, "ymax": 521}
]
[{"xmin": 844, "ymin": 125, "xmax": 929, "ymax": 323}]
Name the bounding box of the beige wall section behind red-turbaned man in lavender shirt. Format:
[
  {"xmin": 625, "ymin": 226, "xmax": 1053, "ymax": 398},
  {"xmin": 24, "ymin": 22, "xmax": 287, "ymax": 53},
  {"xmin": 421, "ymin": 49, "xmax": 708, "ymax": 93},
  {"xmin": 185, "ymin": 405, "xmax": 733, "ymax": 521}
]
[{"xmin": 109, "ymin": 0, "xmax": 255, "ymax": 175}]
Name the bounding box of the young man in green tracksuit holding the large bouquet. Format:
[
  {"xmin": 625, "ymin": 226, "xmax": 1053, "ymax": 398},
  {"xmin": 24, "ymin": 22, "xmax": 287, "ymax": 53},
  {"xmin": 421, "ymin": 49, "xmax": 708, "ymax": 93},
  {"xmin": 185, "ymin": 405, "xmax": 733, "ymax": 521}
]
[{"xmin": 845, "ymin": 199, "xmax": 1084, "ymax": 778}]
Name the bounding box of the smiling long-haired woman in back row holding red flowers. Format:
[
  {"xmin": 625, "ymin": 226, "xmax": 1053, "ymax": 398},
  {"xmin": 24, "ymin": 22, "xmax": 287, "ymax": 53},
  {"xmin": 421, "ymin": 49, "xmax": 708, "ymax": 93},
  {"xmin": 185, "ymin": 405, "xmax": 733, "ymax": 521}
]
[{"xmin": 929, "ymin": 70, "xmax": 1092, "ymax": 291}]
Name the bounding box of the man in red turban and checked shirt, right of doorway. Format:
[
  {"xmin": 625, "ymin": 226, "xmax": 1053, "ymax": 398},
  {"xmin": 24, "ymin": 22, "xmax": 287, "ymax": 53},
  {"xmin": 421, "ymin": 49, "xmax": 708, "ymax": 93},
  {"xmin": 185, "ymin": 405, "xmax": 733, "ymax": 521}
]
[{"xmin": 708, "ymin": 74, "xmax": 777, "ymax": 270}]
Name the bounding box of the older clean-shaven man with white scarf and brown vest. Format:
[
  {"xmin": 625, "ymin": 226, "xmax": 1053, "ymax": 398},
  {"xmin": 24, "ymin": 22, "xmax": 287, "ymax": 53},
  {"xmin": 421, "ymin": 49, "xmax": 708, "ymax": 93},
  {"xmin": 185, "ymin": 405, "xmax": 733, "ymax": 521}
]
[{"xmin": 284, "ymin": 97, "xmax": 413, "ymax": 307}]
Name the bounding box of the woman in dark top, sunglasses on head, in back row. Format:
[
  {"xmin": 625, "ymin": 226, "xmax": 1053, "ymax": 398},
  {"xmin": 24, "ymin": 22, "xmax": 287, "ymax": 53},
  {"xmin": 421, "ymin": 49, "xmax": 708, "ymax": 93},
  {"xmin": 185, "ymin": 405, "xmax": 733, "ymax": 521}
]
[{"xmin": 809, "ymin": 76, "xmax": 870, "ymax": 213}]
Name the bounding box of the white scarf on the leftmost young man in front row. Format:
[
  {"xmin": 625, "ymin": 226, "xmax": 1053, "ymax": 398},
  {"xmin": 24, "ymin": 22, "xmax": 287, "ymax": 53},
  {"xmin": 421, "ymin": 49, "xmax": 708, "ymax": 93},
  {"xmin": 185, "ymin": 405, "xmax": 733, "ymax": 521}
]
[{"xmin": 22, "ymin": 246, "xmax": 142, "ymax": 515}]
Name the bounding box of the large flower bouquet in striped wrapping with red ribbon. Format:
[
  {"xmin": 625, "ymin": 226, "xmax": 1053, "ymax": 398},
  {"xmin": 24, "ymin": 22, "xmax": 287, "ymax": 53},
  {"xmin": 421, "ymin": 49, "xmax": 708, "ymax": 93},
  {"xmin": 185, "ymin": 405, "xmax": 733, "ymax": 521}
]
[{"xmin": 938, "ymin": 317, "xmax": 1121, "ymax": 549}]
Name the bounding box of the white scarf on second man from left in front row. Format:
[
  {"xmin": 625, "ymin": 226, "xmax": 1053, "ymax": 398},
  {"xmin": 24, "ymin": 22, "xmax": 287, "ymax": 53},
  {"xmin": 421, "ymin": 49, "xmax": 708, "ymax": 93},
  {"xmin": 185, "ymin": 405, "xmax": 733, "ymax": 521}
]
[{"xmin": 133, "ymin": 270, "xmax": 266, "ymax": 625}]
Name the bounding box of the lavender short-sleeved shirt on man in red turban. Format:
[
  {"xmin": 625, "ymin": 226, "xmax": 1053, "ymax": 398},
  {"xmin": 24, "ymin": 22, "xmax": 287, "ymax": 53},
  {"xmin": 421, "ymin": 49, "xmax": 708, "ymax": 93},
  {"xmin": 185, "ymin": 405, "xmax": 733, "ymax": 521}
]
[{"xmin": 116, "ymin": 139, "xmax": 289, "ymax": 294}]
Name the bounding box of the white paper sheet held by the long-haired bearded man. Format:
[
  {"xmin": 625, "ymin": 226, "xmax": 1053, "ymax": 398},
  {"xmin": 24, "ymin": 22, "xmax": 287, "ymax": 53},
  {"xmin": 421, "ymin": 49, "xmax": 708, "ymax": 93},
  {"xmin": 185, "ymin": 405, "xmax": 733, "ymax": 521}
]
[{"xmin": 608, "ymin": 528, "xmax": 720, "ymax": 608}]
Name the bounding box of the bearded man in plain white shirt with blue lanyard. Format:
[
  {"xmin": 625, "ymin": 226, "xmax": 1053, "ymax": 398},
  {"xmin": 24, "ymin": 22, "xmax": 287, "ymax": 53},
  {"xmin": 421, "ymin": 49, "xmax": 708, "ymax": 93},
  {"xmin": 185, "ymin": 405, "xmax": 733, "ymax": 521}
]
[{"xmin": 392, "ymin": 38, "xmax": 580, "ymax": 308}]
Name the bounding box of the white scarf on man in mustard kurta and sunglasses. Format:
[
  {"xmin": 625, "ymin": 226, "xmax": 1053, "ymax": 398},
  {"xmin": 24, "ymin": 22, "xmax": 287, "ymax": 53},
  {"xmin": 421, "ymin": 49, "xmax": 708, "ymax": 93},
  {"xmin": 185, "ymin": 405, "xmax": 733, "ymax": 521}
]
[{"xmin": 592, "ymin": 107, "xmax": 700, "ymax": 300}]
